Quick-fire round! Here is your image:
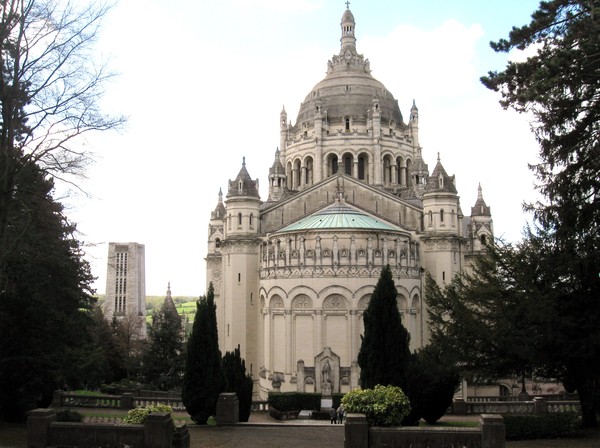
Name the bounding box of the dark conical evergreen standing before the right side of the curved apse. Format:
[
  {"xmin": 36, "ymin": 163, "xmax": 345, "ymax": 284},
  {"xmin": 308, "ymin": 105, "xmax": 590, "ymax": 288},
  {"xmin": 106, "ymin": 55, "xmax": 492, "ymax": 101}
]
[{"xmin": 358, "ymin": 265, "xmax": 411, "ymax": 391}]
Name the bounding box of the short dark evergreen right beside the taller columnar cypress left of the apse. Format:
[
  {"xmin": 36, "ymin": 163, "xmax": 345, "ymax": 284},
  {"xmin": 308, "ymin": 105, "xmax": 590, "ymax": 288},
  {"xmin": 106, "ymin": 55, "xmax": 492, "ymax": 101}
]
[{"xmin": 223, "ymin": 345, "xmax": 254, "ymax": 422}]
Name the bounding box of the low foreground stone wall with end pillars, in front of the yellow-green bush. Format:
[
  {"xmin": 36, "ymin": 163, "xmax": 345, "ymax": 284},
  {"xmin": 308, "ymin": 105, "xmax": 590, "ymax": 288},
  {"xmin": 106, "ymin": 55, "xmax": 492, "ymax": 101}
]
[{"xmin": 344, "ymin": 414, "xmax": 506, "ymax": 448}]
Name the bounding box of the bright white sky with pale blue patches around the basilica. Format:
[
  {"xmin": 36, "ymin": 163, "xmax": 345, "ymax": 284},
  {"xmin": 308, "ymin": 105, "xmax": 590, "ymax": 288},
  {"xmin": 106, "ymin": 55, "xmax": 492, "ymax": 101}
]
[{"xmin": 66, "ymin": 0, "xmax": 538, "ymax": 296}]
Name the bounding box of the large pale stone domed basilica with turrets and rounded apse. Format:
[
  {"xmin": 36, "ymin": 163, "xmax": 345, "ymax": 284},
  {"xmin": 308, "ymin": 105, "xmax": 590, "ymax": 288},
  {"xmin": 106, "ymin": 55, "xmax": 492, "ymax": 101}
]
[{"xmin": 206, "ymin": 9, "xmax": 493, "ymax": 398}]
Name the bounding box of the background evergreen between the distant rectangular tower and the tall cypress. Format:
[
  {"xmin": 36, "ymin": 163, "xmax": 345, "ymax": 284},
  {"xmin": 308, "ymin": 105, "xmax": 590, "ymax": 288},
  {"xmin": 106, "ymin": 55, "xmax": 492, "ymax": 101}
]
[{"xmin": 143, "ymin": 301, "xmax": 184, "ymax": 390}]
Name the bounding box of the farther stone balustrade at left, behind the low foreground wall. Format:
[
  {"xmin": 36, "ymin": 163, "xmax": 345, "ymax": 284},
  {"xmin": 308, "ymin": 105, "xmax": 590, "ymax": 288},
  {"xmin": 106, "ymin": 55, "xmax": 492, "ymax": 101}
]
[{"xmin": 52, "ymin": 390, "xmax": 185, "ymax": 411}]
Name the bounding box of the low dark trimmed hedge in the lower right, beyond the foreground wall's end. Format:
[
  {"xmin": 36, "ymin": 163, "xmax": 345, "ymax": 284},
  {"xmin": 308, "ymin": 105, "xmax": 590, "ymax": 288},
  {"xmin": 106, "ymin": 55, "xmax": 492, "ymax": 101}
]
[{"xmin": 502, "ymin": 412, "xmax": 581, "ymax": 440}]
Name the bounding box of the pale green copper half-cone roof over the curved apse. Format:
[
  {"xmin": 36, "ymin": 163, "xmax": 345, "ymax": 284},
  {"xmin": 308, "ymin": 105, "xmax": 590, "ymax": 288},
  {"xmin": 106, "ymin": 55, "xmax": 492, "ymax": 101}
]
[{"xmin": 276, "ymin": 201, "xmax": 401, "ymax": 233}]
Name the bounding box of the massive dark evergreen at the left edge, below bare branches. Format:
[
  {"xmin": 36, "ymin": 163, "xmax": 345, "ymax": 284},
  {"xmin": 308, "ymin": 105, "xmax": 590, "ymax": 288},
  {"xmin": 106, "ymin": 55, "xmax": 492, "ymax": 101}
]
[{"xmin": 0, "ymin": 162, "xmax": 94, "ymax": 421}]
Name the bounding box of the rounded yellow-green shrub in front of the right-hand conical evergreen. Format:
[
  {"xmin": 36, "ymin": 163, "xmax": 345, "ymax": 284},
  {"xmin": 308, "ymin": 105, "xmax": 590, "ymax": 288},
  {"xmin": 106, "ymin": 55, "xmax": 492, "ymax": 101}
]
[{"xmin": 342, "ymin": 384, "xmax": 410, "ymax": 426}]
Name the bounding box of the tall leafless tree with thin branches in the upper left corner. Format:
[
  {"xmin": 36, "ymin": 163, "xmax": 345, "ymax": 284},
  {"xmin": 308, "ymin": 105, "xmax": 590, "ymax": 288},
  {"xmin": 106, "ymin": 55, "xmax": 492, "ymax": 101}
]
[{"xmin": 0, "ymin": 0, "xmax": 124, "ymax": 292}]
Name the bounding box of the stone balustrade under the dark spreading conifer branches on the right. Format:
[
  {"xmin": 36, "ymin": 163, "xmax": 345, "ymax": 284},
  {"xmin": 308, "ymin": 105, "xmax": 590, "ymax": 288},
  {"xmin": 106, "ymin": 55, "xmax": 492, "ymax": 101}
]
[{"xmin": 452, "ymin": 397, "xmax": 581, "ymax": 415}]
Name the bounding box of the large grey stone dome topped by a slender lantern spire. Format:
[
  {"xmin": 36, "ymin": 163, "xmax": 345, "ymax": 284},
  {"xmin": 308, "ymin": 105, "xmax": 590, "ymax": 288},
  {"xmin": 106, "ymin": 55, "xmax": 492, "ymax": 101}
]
[{"xmin": 296, "ymin": 10, "xmax": 402, "ymax": 126}]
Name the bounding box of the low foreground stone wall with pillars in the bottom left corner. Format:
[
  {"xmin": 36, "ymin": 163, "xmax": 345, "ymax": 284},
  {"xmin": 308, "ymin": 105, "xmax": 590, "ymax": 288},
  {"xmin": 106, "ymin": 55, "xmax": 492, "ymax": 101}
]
[{"xmin": 27, "ymin": 409, "xmax": 190, "ymax": 448}]
